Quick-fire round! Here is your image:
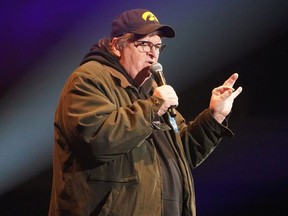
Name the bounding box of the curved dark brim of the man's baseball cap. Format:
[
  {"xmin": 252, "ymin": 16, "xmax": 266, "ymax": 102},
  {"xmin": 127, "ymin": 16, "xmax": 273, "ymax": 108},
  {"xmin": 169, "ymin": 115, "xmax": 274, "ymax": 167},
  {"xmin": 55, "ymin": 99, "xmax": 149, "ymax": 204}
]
[{"xmin": 131, "ymin": 23, "xmax": 175, "ymax": 38}]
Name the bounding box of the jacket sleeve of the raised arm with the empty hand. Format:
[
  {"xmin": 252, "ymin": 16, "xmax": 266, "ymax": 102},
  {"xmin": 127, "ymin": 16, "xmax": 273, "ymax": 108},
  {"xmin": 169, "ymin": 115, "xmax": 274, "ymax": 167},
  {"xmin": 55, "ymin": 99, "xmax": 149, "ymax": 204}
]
[{"xmin": 179, "ymin": 109, "xmax": 234, "ymax": 169}]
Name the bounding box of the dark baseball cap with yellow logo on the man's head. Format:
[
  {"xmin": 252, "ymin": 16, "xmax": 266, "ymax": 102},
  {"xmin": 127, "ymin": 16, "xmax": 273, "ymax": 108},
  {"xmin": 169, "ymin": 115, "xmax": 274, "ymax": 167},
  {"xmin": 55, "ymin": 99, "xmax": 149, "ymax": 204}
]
[{"xmin": 110, "ymin": 9, "xmax": 175, "ymax": 38}]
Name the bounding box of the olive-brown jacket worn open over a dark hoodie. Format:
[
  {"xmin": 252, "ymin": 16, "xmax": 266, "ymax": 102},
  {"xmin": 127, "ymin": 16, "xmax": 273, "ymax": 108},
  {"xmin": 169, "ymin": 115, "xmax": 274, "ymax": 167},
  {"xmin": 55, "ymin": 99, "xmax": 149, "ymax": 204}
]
[{"xmin": 49, "ymin": 61, "xmax": 233, "ymax": 216}]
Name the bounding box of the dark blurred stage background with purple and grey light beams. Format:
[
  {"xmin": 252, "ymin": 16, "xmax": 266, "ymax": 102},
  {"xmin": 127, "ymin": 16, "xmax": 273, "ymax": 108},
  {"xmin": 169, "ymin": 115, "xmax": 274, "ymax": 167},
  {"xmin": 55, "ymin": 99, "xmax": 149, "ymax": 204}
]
[{"xmin": 0, "ymin": 0, "xmax": 288, "ymax": 216}]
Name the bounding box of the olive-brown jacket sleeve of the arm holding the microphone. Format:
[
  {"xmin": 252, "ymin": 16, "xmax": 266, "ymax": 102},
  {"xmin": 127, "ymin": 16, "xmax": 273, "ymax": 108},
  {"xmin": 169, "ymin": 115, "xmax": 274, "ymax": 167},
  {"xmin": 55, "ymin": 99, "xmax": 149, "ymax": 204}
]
[{"xmin": 56, "ymin": 66, "xmax": 162, "ymax": 162}]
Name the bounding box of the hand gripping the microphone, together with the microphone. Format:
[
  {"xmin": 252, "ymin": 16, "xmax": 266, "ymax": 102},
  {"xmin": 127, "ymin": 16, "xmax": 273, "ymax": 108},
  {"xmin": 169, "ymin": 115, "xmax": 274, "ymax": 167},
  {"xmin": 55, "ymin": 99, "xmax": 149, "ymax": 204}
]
[{"xmin": 150, "ymin": 63, "xmax": 178, "ymax": 117}]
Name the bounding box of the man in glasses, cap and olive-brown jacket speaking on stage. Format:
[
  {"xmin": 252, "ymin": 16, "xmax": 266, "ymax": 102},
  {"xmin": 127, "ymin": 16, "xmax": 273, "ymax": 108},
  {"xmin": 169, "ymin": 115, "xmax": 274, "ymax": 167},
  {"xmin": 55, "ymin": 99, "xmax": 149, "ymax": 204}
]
[{"xmin": 49, "ymin": 9, "xmax": 242, "ymax": 216}]
